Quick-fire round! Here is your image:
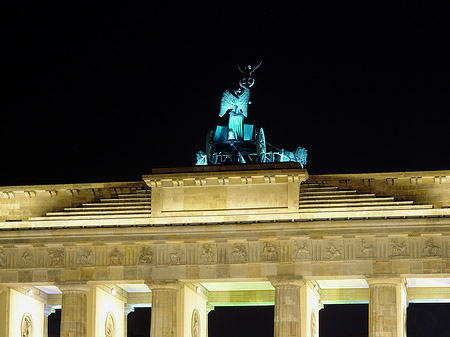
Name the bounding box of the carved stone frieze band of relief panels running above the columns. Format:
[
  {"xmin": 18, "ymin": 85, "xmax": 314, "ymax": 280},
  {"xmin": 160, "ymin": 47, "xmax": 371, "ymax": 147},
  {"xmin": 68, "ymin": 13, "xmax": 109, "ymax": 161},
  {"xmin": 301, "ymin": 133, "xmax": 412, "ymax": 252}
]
[{"xmin": 0, "ymin": 235, "xmax": 450, "ymax": 269}]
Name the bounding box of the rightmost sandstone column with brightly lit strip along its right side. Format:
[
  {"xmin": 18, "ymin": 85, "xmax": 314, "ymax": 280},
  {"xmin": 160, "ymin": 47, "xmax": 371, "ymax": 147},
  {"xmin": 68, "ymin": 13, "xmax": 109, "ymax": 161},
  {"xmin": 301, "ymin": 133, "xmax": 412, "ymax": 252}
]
[{"xmin": 367, "ymin": 278, "xmax": 407, "ymax": 337}]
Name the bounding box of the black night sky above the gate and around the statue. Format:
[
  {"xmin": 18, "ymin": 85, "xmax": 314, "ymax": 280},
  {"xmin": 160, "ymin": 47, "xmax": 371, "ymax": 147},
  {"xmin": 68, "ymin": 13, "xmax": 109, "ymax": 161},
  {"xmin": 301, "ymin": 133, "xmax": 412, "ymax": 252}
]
[{"xmin": 5, "ymin": 0, "xmax": 450, "ymax": 337}]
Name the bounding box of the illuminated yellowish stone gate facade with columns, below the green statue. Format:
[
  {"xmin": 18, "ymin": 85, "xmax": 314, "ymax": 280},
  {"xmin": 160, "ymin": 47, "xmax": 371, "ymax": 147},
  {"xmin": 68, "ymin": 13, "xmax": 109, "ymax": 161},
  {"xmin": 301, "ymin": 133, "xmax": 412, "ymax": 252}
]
[{"xmin": 0, "ymin": 164, "xmax": 450, "ymax": 337}]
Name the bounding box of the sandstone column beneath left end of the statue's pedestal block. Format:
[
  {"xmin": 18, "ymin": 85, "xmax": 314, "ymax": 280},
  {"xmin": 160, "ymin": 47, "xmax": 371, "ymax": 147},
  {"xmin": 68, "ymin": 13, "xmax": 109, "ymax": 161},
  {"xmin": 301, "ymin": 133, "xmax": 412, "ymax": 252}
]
[{"xmin": 147, "ymin": 281, "xmax": 180, "ymax": 337}]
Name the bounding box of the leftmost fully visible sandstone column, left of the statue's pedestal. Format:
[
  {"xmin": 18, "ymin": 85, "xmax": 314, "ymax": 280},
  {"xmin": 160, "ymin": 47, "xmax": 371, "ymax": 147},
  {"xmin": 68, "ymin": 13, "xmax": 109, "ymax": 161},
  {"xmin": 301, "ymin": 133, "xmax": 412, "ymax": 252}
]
[{"xmin": 58, "ymin": 283, "xmax": 90, "ymax": 337}]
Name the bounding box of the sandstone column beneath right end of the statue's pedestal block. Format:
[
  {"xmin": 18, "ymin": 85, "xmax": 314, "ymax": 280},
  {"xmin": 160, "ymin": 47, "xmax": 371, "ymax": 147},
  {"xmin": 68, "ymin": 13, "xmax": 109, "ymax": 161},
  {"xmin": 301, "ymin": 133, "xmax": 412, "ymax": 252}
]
[{"xmin": 270, "ymin": 278, "xmax": 305, "ymax": 337}]
